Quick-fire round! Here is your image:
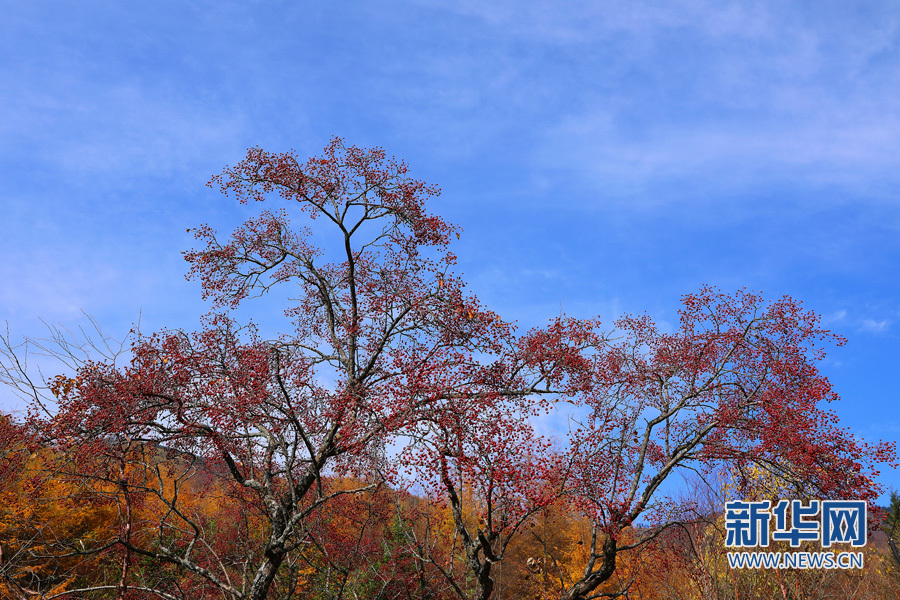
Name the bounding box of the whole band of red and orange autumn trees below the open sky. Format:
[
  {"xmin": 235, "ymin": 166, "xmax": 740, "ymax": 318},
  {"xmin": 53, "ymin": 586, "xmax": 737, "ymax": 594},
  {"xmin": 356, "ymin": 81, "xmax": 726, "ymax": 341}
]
[{"xmin": 0, "ymin": 138, "xmax": 895, "ymax": 600}]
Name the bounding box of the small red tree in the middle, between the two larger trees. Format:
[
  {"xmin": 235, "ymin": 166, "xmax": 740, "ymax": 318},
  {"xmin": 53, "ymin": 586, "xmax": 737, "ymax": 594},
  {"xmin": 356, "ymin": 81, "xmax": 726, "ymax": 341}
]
[{"xmin": 409, "ymin": 405, "xmax": 557, "ymax": 600}]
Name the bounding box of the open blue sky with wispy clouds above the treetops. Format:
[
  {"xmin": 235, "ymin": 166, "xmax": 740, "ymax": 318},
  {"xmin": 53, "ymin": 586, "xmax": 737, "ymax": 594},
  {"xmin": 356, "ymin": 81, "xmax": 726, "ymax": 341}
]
[{"xmin": 0, "ymin": 0, "xmax": 900, "ymax": 496}]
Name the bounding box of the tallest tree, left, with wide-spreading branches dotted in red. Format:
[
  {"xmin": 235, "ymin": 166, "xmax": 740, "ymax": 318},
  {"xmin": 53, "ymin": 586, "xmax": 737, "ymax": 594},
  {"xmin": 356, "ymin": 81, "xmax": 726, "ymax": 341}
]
[{"xmin": 3, "ymin": 139, "xmax": 524, "ymax": 599}]
